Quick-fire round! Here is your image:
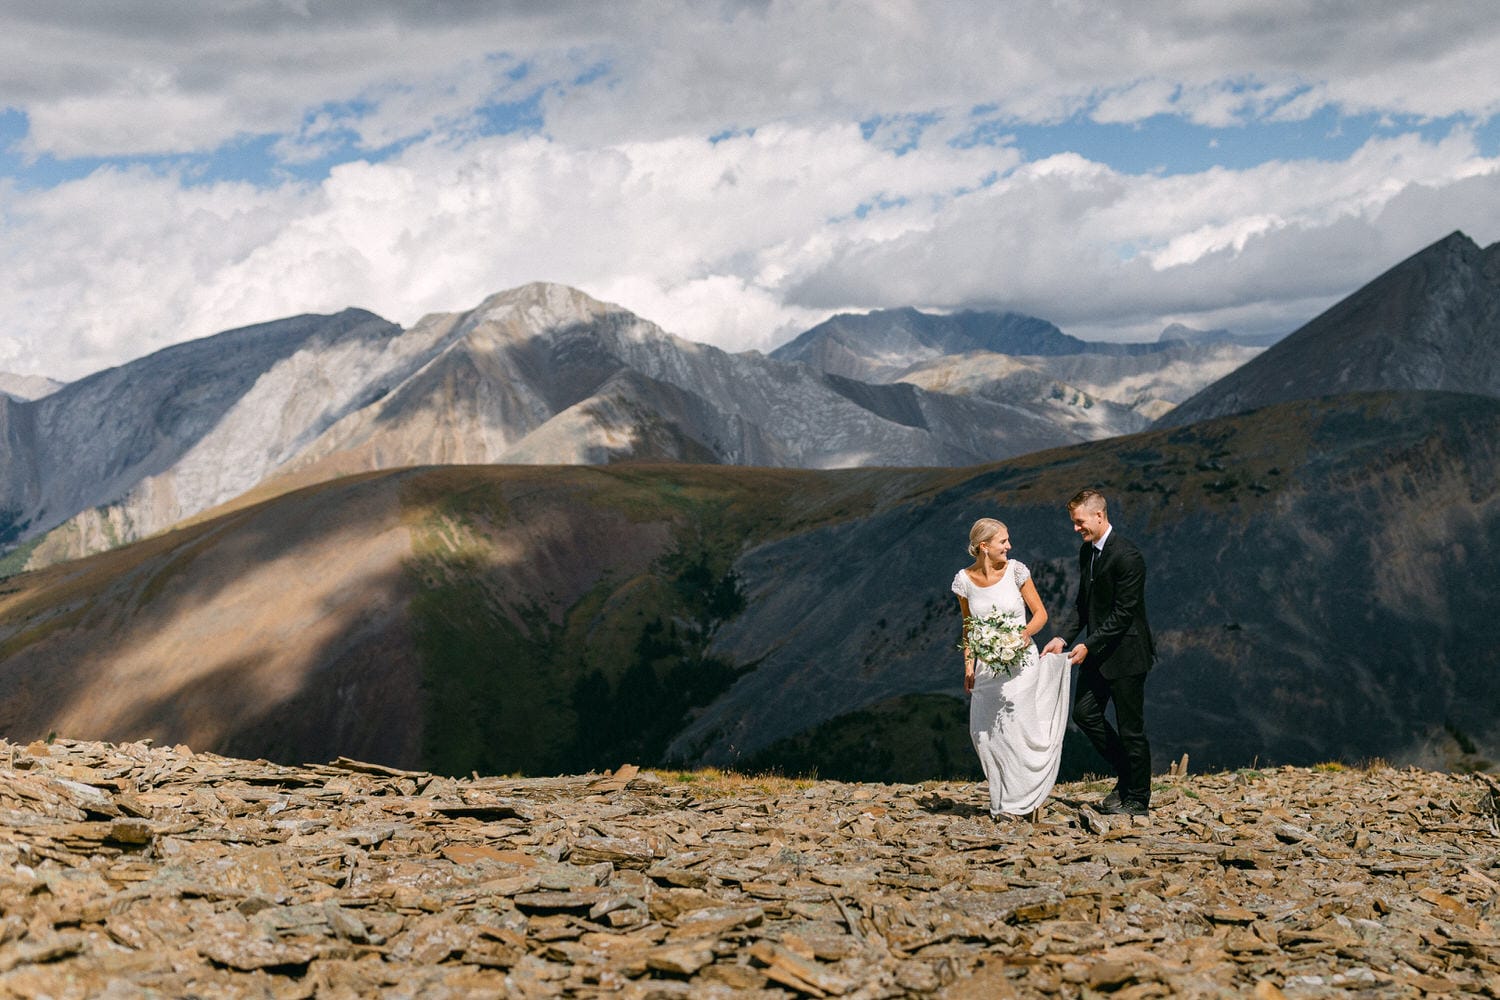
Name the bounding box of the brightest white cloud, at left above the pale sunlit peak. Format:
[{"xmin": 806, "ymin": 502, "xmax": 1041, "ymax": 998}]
[{"xmin": 0, "ymin": 126, "xmax": 1016, "ymax": 376}]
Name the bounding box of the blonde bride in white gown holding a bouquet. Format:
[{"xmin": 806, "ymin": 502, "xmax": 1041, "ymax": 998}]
[{"xmin": 953, "ymin": 517, "xmax": 1070, "ymax": 820}]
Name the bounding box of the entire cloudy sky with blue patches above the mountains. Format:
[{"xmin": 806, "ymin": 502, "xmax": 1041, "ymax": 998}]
[{"xmin": 0, "ymin": 0, "xmax": 1500, "ymax": 379}]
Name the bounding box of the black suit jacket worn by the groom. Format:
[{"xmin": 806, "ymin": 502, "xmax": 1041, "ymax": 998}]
[{"xmin": 1058, "ymin": 531, "xmax": 1157, "ymax": 681}]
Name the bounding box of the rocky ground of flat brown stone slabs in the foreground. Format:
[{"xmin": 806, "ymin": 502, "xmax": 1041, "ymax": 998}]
[{"xmin": 0, "ymin": 739, "xmax": 1500, "ymax": 999}]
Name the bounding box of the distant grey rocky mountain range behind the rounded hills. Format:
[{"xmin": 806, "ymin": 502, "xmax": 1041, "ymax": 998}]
[{"xmin": 0, "ymin": 283, "xmax": 1248, "ymax": 570}]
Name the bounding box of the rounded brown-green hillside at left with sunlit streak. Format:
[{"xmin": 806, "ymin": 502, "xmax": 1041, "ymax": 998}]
[{"xmin": 0, "ymin": 465, "xmax": 944, "ymax": 774}]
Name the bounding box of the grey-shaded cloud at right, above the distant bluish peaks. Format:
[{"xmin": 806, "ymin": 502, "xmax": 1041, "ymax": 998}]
[{"xmin": 791, "ymin": 130, "xmax": 1500, "ymax": 336}]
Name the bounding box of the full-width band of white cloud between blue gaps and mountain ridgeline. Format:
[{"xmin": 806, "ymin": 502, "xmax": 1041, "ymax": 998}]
[{"xmin": 0, "ymin": 119, "xmax": 1500, "ymax": 376}]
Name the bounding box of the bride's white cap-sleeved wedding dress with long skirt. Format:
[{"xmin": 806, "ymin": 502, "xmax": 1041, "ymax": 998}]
[{"xmin": 953, "ymin": 559, "xmax": 1071, "ymax": 817}]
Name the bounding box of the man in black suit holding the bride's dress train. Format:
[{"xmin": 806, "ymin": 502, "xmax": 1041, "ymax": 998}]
[{"xmin": 1043, "ymin": 490, "xmax": 1157, "ymax": 816}]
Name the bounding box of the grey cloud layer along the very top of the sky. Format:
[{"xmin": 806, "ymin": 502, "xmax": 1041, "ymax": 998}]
[{"xmin": 0, "ymin": 0, "xmax": 1500, "ymax": 156}]
